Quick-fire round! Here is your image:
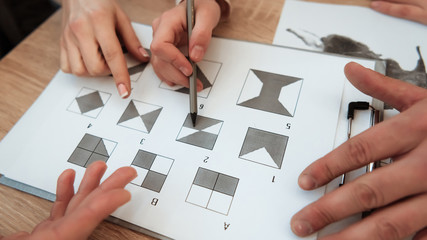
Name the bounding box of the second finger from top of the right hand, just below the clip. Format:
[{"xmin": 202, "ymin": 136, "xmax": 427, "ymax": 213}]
[{"xmin": 298, "ymin": 96, "xmax": 427, "ymax": 190}]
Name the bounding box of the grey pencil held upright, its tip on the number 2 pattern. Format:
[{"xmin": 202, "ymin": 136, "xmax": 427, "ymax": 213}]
[{"xmin": 187, "ymin": 0, "xmax": 197, "ymax": 127}]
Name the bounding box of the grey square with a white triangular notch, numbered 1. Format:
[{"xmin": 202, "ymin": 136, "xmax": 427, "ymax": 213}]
[{"xmin": 239, "ymin": 128, "xmax": 289, "ymax": 169}]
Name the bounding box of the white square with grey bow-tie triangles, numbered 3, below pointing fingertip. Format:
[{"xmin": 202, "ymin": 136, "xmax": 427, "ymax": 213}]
[{"xmin": 117, "ymin": 100, "xmax": 162, "ymax": 133}]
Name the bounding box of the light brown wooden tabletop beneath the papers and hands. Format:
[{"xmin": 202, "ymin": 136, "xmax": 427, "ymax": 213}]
[{"xmin": 0, "ymin": 0, "xmax": 369, "ymax": 240}]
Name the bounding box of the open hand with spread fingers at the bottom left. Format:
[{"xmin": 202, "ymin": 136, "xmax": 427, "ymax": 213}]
[{"xmin": 0, "ymin": 161, "xmax": 136, "ymax": 240}]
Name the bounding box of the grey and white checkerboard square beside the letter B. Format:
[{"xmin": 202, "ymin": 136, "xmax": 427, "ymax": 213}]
[{"xmin": 131, "ymin": 150, "xmax": 174, "ymax": 192}]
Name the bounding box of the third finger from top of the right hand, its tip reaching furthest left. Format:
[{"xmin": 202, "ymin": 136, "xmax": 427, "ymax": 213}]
[{"xmin": 291, "ymin": 152, "xmax": 427, "ymax": 236}]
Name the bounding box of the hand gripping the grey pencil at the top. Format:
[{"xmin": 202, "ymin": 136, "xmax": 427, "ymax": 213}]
[{"xmin": 151, "ymin": 0, "xmax": 221, "ymax": 91}]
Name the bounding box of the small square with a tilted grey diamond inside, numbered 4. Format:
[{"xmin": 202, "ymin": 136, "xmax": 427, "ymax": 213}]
[{"xmin": 67, "ymin": 88, "xmax": 111, "ymax": 118}]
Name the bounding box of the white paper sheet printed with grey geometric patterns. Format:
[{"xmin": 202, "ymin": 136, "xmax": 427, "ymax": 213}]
[{"xmin": 0, "ymin": 24, "xmax": 374, "ymax": 239}]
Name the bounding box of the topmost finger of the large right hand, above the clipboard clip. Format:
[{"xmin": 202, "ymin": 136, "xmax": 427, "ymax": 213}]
[{"xmin": 344, "ymin": 62, "xmax": 427, "ymax": 111}]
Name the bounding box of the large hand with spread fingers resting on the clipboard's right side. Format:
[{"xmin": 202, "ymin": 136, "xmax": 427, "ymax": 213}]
[{"xmin": 291, "ymin": 63, "xmax": 427, "ymax": 239}]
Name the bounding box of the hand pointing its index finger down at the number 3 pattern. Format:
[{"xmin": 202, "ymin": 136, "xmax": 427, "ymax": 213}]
[{"xmin": 60, "ymin": 0, "xmax": 149, "ymax": 98}]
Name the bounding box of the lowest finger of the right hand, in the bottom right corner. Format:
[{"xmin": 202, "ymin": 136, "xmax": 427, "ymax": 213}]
[{"xmin": 322, "ymin": 194, "xmax": 427, "ymax": 240}]
